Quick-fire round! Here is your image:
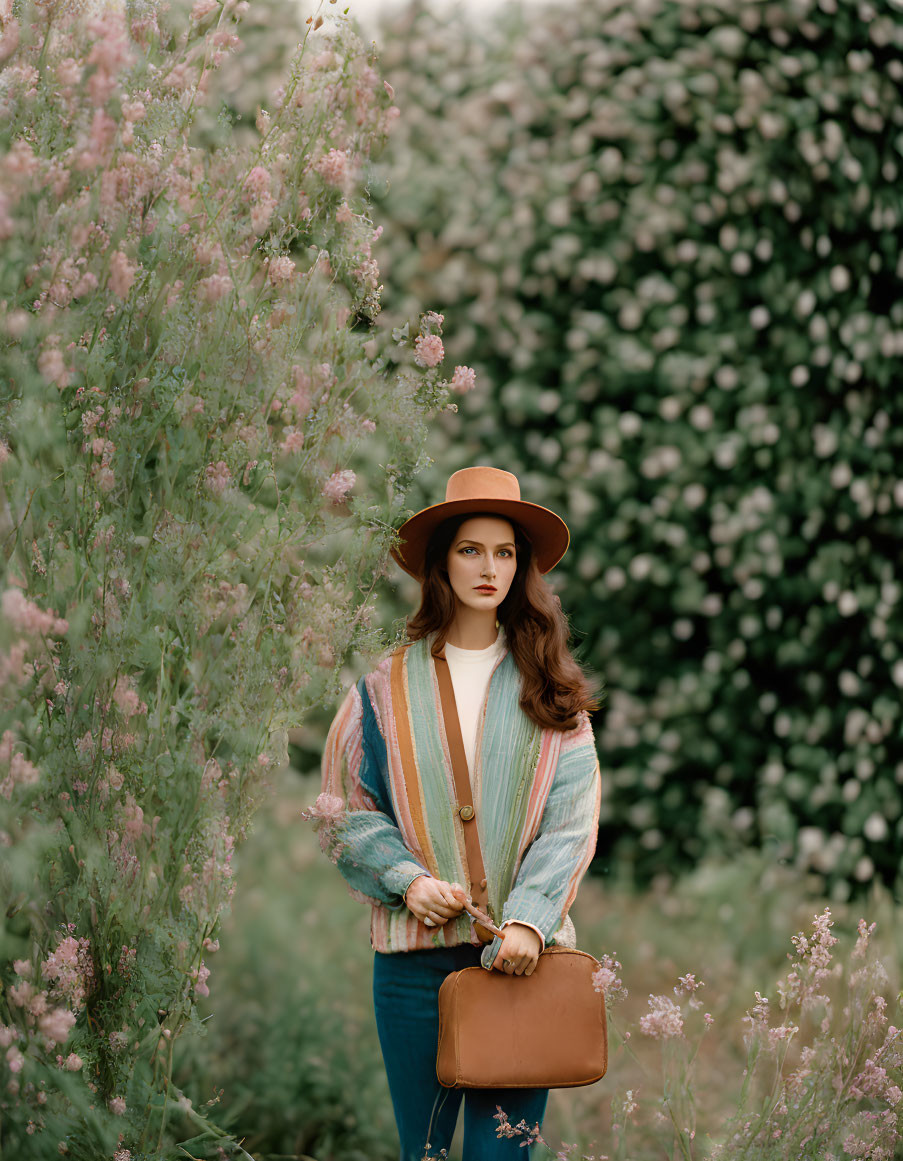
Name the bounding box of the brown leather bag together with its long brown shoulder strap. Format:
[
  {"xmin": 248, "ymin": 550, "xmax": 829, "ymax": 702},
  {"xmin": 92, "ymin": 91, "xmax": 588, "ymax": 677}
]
[{"xmin": 427, "ymin": 656, "xmax": 608, "ymax": 1088}]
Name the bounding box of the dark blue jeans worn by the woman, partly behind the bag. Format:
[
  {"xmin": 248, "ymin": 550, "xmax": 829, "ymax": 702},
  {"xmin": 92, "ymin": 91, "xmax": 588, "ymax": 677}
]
[{"xmin": 373, "ymin": 944, "xmax": 549, "ymax": 1161}]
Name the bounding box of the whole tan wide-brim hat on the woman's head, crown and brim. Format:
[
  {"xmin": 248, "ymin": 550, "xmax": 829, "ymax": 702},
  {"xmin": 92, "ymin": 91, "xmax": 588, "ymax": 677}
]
[{"xmin": 392, "ymin": 468, "xmax": 571, "ymax": 581}]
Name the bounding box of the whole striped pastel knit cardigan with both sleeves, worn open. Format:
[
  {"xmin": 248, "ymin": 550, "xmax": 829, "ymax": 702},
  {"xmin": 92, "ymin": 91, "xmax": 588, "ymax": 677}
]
[{"xmin": 308, "ymin": 637, "xmax": 601, "ymax": 967}]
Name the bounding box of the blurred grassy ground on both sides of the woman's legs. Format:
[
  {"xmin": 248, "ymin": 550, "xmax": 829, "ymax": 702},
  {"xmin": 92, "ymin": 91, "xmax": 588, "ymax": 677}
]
[{"xmin": 173, "ymin": 770, "xmax": 903, "ymax": 1161}]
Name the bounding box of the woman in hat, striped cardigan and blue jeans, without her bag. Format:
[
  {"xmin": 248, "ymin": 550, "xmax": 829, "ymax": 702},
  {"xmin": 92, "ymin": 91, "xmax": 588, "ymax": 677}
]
[{"xmin": 312, "ymin": 467, "xmax": 600, "ymax": 1161}]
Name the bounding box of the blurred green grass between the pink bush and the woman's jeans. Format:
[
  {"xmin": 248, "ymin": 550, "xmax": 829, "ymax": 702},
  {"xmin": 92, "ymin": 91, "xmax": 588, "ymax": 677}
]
[{"xmin": 174, "ymin": 770, "xmax": 397, "ymax": 1161}]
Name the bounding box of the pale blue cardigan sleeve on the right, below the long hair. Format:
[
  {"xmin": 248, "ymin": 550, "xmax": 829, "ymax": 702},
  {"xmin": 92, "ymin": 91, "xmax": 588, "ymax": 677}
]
[{"xmin": 492, "ymin": 711, "xmax": 601, "ymax": 958}]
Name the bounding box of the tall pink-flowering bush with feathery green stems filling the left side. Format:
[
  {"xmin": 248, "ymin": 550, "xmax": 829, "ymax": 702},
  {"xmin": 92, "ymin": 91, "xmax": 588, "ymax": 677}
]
[{"xmin": 0, "ymin": 0, "xmax": 464, "ymax": 1161}]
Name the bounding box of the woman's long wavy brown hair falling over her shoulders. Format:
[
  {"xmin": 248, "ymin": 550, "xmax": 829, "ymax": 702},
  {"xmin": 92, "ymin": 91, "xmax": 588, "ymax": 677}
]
[{"xmin": 406, "ymin": 512, "xmax": 599, "ymax": 730}]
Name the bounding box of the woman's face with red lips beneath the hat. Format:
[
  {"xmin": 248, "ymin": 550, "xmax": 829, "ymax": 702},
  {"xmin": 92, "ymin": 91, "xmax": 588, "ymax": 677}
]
[{"xmin": 447, "ymin": 515, "xmax": 518, "ymax": 610}]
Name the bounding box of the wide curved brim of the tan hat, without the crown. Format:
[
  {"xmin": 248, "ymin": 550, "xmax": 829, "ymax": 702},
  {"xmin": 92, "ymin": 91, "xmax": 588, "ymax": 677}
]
[{"xmin": 391, "ymin": 499, "xmax": 571, "ymax": 581}]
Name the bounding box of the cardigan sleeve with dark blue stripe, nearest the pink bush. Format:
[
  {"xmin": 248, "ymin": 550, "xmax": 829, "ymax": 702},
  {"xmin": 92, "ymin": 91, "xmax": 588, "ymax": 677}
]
[{"xmin": 304, "ymin": 678, "xmax": 429, "ymax": 910}]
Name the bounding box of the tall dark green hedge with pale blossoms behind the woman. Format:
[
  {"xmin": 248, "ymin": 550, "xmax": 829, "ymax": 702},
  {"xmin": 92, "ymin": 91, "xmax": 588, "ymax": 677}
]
[{"xmin": 371, "ymin": 0, "xmax": 903, "ymax": 899}]
